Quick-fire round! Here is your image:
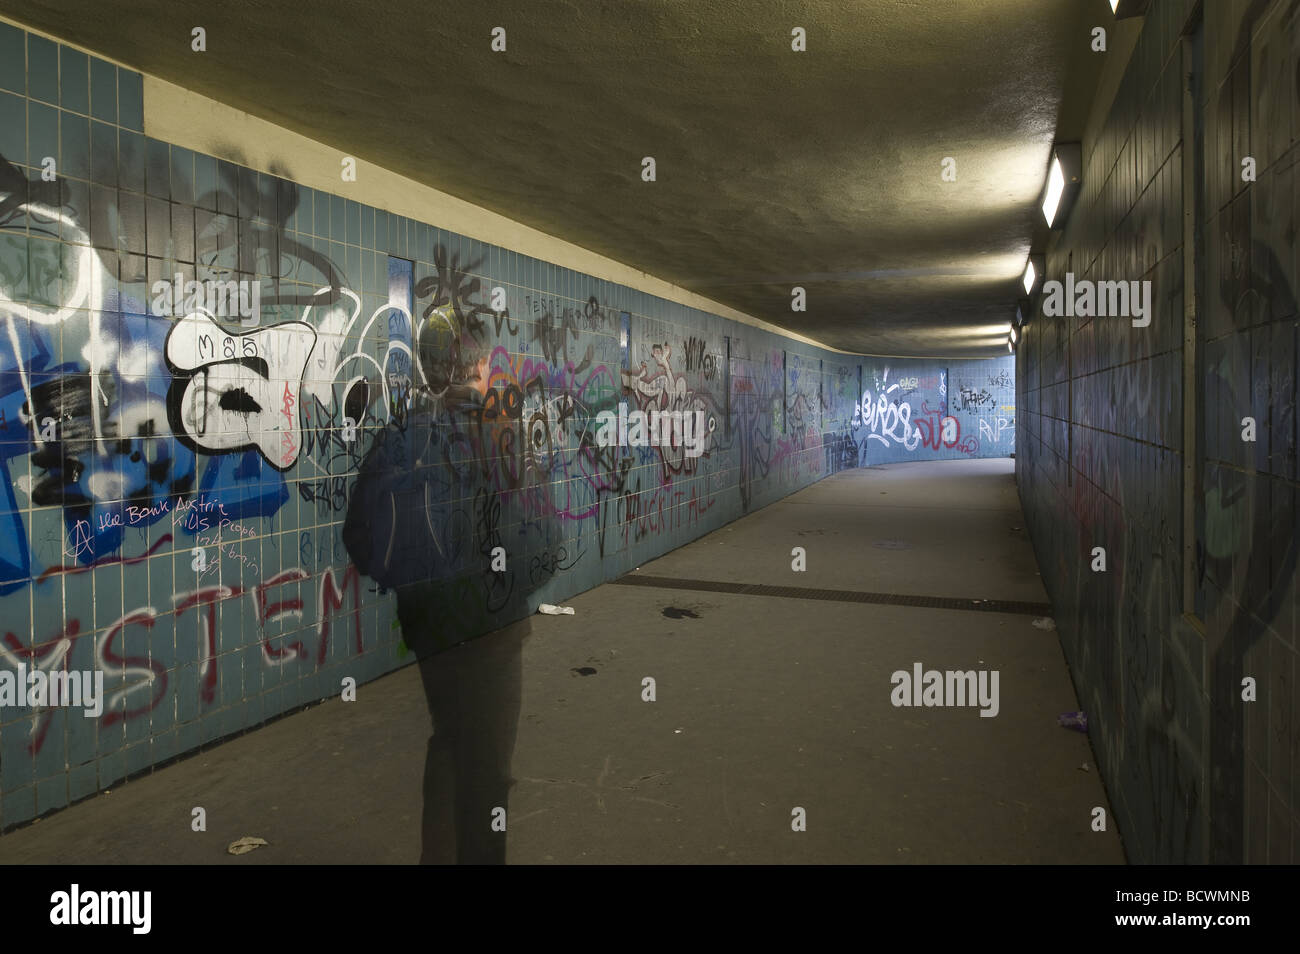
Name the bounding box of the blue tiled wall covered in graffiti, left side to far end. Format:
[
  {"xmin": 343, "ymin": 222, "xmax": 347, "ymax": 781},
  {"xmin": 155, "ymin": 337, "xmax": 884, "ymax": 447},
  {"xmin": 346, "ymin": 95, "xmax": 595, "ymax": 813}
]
[{"xmin": 0, "ymin": 25, "xmax": 1014, "ymax": 825}]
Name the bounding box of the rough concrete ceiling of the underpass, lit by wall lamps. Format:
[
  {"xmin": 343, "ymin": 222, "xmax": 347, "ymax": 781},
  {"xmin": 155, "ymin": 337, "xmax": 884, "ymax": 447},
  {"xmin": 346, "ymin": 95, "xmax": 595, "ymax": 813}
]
[{"xmin": 0, "ymin": 0, "xmax": 1113, "ymax": 357}]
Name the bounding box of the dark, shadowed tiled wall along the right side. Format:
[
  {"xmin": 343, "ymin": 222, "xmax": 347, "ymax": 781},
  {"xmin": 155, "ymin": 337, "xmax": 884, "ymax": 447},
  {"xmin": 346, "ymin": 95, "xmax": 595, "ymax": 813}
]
[{"xmin": 1017, "ymin": 0, "xmax": 1300, "ymax": 863}]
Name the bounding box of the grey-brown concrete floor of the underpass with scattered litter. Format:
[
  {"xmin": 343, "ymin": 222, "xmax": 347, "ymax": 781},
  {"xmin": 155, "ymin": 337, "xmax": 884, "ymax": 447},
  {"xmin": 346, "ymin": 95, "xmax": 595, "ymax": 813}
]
[{"xmin": 0, "ymin": 460, "xmax": 1125, "ymax": 864}]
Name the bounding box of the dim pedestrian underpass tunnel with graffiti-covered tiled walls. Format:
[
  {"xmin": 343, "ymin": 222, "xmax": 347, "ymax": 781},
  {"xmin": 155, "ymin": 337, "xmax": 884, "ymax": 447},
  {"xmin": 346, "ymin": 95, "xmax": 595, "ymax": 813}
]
[{"xmin": 0, "ymin": 0, "xmax": 1300, "ymax": 864}]
